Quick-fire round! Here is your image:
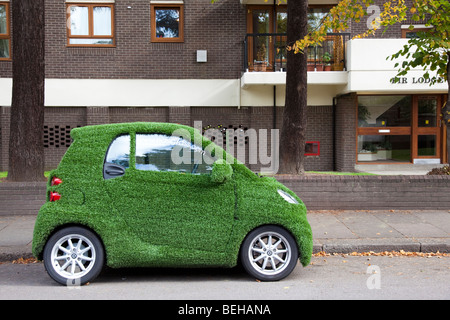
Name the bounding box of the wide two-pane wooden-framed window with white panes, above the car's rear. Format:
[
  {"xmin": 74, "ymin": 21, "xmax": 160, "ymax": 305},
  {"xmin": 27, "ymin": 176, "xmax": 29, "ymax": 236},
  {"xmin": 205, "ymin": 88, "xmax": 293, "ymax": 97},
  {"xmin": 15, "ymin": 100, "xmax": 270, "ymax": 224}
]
[{"xmin": 67, "ymin": 3, "xmax": 115, "ymax": 47}]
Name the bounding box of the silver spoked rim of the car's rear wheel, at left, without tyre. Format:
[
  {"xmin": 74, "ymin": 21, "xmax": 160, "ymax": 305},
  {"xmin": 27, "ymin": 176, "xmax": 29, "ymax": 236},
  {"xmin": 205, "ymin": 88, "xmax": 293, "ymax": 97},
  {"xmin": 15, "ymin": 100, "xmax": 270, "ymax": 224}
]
[{"xmin": 51, "ymin": 234, "xmax": 96, "ymax": 279}]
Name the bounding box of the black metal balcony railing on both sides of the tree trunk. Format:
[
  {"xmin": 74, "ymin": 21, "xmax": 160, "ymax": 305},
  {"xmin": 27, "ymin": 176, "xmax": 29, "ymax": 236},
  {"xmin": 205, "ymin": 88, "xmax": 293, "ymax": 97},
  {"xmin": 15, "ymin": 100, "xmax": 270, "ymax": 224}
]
[{"xmin": 244, "ymin": 33, "xmax": 350, "ymax": 72}]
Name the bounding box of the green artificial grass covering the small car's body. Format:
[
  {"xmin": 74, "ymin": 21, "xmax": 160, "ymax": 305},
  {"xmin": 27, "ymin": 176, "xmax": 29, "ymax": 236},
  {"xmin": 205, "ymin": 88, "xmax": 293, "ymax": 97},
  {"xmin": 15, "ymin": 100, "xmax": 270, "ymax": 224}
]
[{"xmin": 32, "ymin": 123, "xmax": 312, "ymax": 267}]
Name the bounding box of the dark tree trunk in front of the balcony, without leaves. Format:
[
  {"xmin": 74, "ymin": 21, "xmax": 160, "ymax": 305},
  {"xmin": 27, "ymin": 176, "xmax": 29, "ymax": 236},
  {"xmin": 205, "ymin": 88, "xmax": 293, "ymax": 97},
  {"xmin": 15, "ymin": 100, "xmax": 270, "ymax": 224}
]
[{"xmin": 279, "ymin": 0, "xmax": 308, "ymax": 174}]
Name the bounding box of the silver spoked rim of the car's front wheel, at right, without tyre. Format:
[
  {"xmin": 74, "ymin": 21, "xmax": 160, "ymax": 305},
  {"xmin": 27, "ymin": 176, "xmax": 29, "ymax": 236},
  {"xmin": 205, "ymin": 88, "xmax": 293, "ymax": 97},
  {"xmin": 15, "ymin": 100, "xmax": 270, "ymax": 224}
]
[{"xmin": 248, "ymin": 232, "xmax": 291, "ymax": 275}]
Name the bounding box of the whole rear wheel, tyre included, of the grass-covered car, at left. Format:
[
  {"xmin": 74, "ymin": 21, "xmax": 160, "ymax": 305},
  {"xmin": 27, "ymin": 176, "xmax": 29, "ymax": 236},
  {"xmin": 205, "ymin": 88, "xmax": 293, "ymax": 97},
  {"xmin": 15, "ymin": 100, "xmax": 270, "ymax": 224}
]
[{"xmin": 43, "ymin": 227, "xmax": 105, "ymax": 286}]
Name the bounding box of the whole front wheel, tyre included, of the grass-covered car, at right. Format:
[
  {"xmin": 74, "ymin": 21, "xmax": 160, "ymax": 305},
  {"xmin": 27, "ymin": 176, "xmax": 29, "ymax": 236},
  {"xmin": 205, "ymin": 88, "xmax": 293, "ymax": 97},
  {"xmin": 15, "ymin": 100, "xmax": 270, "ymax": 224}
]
[{"xmin": 240, "ymin": 225, "xmax": 298, "ymax": 281}]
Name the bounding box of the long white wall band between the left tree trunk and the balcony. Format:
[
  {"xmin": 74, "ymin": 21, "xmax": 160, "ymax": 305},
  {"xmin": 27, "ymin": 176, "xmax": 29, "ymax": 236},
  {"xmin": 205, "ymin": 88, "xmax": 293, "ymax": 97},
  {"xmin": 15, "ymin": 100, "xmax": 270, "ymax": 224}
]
[{"xmin": 45, "ymin": 79, "xmax": 239, "ymax": 107}]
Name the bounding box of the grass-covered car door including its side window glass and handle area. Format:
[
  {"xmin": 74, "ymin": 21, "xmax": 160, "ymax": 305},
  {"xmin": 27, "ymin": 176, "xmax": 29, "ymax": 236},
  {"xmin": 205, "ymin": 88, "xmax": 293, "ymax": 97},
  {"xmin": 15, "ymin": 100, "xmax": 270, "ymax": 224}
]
[{"xmin": 104, "ymin": 134, "xmax": 235, "ymax": 253}]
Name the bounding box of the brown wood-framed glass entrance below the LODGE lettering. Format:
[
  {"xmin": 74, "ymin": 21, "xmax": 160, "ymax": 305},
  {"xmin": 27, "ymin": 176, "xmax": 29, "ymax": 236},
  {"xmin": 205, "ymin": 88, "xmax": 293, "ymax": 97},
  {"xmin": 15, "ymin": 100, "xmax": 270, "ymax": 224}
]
[{"xmin": 357, "ymin": 95, "xmax": 442, "ymax": 163}]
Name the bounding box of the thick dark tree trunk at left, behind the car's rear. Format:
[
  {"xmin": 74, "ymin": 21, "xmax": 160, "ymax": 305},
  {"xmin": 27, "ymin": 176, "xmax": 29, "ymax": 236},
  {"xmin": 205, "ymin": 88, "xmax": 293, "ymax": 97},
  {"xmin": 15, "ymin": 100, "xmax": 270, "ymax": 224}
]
[{"xmin": 8, "ymin": 0, "xmax": 45, "ymax": 181}]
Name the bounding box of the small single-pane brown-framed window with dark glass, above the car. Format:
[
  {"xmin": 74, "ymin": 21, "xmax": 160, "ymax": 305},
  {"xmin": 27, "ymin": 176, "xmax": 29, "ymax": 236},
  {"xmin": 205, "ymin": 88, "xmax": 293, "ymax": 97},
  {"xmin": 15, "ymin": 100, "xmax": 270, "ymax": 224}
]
[{"xmin": 150, "ymin": 4, "xmax": 184, "ymax": 42}]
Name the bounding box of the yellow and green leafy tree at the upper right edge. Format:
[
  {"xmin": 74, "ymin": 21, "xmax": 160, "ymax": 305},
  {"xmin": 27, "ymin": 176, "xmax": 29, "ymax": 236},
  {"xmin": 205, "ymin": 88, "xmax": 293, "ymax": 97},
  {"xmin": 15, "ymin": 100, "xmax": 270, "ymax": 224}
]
[{"xmin": 288, "ymin": 0, "xmax": 450, "ymax": 168}]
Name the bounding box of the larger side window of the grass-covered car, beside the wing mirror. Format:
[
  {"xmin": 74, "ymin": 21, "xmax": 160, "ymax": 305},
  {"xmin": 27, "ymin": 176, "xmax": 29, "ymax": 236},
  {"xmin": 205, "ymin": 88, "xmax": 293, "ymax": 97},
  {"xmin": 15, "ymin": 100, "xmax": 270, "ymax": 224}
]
[{"xmin": 136, "ymin": 134, "xmax": 214, "ymax": 174}]
